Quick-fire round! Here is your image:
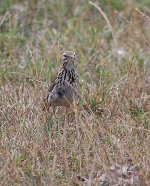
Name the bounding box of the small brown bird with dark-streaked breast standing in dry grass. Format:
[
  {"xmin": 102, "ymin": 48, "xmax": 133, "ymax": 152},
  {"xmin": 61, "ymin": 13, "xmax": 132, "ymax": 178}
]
[{"xmin": 44, "ymin": 51, "xmax": 79, "ymax": 115}]
